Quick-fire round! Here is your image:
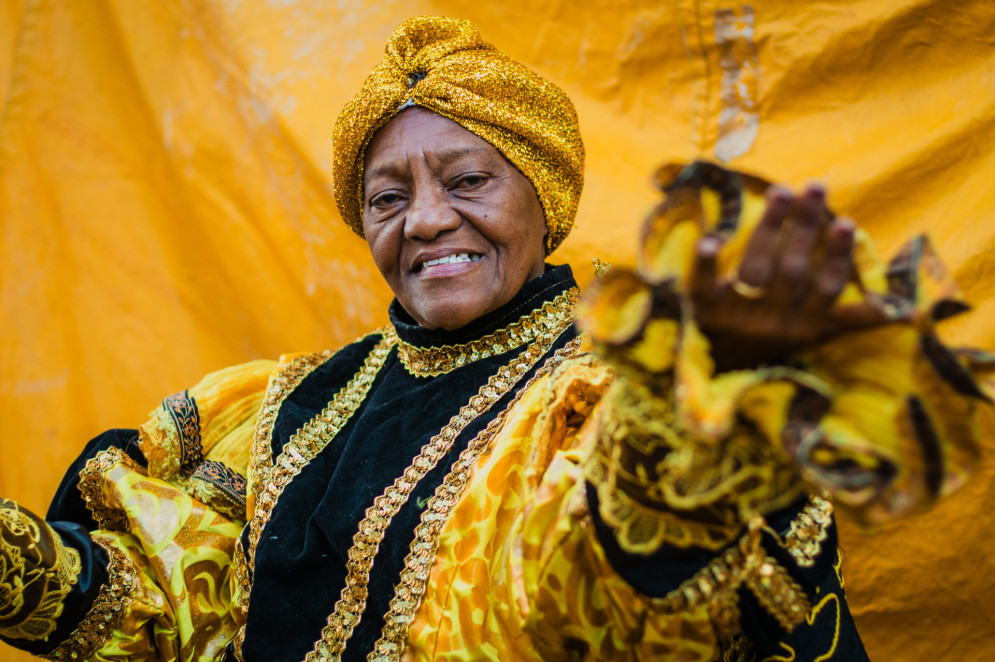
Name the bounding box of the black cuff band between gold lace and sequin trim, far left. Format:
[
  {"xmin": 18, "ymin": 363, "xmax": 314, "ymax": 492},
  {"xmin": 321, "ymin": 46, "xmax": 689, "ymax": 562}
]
[{"xmin": 0, "ymin": 522, "xmax": 107, "ymax": 655}]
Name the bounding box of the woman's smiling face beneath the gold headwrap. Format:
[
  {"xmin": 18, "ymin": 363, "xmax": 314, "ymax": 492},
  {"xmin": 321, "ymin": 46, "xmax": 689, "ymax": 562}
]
[{"xmin": 363, "ymin": 107, "xmax": 546, "ymax": 329}]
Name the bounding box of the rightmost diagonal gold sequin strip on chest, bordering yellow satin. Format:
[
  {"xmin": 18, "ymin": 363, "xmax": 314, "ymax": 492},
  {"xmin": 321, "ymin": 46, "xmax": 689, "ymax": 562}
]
[{"xmin": 366, "ymin": 338, "xmax": 581, "ymax": 662}]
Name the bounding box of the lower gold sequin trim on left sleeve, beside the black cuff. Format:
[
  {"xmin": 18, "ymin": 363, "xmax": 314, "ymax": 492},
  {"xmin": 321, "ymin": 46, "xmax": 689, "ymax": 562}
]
[{"xmin": 43, "ymin": 536, "xmax": 138, "ymax": 660}]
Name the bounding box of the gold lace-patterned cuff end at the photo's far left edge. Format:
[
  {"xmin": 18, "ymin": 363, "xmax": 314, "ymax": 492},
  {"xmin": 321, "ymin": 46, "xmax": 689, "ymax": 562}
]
[{"xmin": 0, "ymin": 499, "xmax": 82, "ymax": 641}]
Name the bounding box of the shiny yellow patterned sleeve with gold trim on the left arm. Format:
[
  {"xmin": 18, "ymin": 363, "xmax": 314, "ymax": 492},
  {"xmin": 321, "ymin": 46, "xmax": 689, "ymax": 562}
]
[{"xmin": 47, "ymin": 448, "xmax": 243, "ymax": 660}]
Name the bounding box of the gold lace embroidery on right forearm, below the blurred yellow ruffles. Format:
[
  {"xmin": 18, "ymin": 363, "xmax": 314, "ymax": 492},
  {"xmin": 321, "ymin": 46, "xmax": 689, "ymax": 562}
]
[{"xmin": 584, "ymin": 371, "xmax": 803, "ymax": 553}]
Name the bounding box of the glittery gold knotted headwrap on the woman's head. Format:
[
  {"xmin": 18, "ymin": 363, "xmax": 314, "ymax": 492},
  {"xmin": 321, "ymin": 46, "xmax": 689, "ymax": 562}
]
[{"xmin": 333, "ymin": 17, "xmax": 584, "ymax": 253}]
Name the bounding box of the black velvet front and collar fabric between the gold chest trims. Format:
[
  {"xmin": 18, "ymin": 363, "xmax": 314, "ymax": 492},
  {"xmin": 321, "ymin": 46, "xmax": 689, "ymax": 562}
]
[{"xmin": 243, "ymin": 267, "xmax": 575, "ymax": 662}]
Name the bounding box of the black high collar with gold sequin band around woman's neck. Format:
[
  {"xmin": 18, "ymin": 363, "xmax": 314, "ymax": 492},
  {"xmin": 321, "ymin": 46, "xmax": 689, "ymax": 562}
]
[{"xmin": 389, "ymin": 265, "xmax": 578, "ymax": 377}]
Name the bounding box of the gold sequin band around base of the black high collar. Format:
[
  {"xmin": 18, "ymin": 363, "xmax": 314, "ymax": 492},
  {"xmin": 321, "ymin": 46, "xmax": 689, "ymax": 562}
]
[{"xmin": 397, "ymin": 287, "xmax": 579, "ymax": 377}]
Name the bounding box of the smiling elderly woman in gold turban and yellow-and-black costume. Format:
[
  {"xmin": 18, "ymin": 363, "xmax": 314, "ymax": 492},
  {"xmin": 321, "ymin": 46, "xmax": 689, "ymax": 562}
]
[{"xmin": 0, "ymin": 18, "xmax": 984, "ymax": 661}]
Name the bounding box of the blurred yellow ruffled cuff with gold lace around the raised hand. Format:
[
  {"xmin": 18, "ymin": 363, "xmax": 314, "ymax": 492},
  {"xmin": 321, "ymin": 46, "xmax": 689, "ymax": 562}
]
[{"xmin": 579, "ymin": 163, "xmax": 992, "ymax": 552}]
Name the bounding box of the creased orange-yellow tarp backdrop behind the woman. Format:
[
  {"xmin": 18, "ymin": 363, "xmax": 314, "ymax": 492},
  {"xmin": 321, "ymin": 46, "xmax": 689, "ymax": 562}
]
[{"xmin": 0, "ymin": 0, "xmax": 995, "ymax": 661}]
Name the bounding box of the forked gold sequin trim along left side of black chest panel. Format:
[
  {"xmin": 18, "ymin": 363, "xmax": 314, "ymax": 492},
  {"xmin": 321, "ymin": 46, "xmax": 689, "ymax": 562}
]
[{"xmin": 233, "ymin": 329, "xmax": 397, "ymax": 659}]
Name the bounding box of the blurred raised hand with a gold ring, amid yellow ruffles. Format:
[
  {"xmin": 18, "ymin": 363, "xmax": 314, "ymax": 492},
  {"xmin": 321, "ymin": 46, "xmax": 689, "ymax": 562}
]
[{"xmin": 690, "ymin": 184, "xmax": 883, "ymax": 372}]
